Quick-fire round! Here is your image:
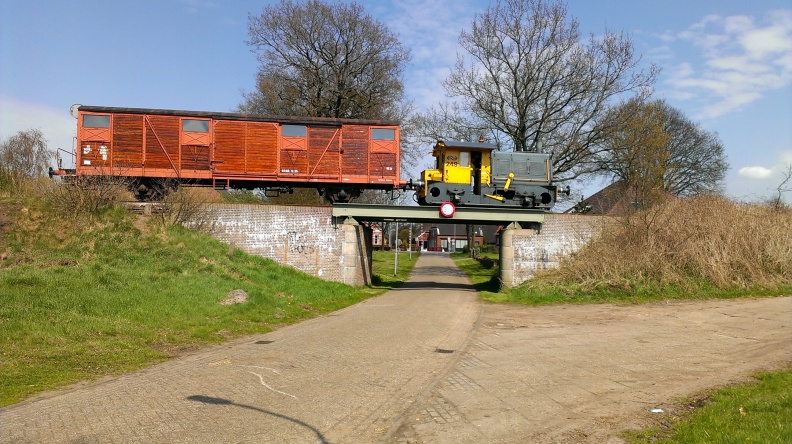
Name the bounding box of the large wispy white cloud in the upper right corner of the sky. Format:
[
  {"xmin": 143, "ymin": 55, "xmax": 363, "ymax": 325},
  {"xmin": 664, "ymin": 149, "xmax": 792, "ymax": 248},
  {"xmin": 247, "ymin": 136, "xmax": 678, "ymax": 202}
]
[{"xmin": 664, "ymin": 10, "xmax": 792, "ymax": 118}]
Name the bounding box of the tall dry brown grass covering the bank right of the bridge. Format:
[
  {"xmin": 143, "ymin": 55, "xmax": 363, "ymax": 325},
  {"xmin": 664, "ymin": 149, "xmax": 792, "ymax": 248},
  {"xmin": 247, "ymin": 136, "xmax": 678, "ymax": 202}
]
[{"xmin": 559, "ymin": 195, "xmax": 792, "ymax": 288}]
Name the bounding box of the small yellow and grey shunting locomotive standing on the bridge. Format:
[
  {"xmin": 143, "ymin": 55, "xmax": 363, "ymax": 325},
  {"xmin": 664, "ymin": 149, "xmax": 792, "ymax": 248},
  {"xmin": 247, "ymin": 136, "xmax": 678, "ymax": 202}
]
[{"xmin": 416, "ymin": 141, "xmax": 566, "ymax": 210}]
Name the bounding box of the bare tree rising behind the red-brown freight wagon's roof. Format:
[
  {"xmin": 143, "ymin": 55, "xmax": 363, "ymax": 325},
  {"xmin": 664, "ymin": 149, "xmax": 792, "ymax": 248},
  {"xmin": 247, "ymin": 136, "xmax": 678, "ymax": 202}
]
[{"xmin": 239, "ymin": 0, "xmax": 410, "ymax": 119}]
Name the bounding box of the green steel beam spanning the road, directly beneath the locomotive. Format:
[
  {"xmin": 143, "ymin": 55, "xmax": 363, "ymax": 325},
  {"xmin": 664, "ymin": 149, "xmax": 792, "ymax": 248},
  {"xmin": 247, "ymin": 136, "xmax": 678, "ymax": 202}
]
[{"xmin": 333, "ymin": 204, "xmax": 545, "ymax": 228}]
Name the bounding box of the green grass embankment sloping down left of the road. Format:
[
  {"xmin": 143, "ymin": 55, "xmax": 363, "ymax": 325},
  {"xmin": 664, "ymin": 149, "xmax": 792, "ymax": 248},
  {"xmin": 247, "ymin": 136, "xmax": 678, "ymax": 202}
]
[{"xmin": 0, "ymin": 202, "xmax": 417, "ymax": 406}]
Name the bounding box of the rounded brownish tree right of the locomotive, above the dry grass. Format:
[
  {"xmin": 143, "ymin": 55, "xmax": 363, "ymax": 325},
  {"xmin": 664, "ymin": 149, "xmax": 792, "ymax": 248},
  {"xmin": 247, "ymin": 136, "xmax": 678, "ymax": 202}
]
[{"xmin": 593, "ymin": 98, "xmax": 729, "ymax": 196}]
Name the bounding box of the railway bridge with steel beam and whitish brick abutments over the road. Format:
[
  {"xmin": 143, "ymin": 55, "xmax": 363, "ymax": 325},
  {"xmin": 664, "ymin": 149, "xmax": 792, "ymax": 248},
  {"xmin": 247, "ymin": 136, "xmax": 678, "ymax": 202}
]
[{"xmin": 186, "ymin": 204, "xmax": 601, "ymax": 287}]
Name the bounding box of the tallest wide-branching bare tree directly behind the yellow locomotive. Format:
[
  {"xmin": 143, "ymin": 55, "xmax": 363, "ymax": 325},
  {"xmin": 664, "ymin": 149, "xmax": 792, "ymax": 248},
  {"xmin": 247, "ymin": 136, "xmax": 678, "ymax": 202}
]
[{"xmin": 434, "ymin": 0, "xmax": 658, "ymax": 179}]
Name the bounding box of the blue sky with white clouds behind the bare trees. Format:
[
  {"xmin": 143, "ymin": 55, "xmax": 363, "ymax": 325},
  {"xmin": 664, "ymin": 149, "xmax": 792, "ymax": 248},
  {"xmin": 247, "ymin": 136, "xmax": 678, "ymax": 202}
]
[{"xmin": 0, "ymin": 0, "xmax": 792, "ymax": 201}]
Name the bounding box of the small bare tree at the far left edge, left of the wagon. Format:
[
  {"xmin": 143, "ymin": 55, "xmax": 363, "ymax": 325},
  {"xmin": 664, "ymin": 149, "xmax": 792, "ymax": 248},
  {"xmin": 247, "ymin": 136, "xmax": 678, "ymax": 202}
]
[{"xmin": 0, "ymin": 129, "xmax": 51, "ymax": 194}]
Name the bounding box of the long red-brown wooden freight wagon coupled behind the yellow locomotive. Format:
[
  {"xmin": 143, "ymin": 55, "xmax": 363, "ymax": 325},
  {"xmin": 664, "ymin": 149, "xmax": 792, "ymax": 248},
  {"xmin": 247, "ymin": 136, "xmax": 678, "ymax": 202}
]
[{"xmin": 66, "ymin": 105, "xmax": 400, "ymax": 200}]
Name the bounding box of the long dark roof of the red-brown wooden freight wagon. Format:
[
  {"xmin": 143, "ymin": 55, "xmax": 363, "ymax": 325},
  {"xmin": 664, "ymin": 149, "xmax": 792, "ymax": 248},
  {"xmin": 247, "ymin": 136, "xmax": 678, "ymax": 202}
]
[{"xmin": 78, "ymin": 105, "xmax": 399, "ymax": 126}]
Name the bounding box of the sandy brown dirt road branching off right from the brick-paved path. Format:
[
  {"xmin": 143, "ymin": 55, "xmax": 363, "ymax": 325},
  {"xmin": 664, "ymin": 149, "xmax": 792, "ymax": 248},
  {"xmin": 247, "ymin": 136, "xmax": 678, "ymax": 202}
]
[{"xmin": 397, "ymin": 297, "xmax": 792, "ymax": 443}]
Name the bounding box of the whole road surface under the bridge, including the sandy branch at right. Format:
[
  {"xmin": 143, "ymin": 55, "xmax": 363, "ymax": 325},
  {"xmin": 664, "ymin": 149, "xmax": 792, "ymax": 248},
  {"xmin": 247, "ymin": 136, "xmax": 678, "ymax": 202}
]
[{"xmin": 0, "ymin": 254, "xmax": 792, "ymax": 443}]
